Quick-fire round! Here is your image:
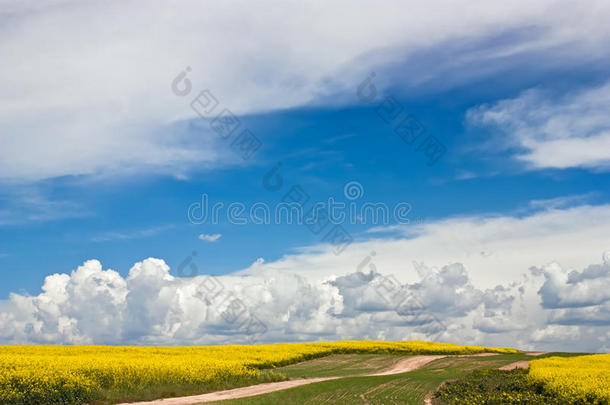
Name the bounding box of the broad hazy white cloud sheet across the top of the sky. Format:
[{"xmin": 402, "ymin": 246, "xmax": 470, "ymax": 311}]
[{"xmin": 0, "ymin": 0, "xmax": 610, "ymax": 181}]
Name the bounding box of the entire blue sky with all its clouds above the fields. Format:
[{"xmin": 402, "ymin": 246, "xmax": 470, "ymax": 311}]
[{"xmin": 0, "ymin": 2, "xmax": 610, "ymax": 351}]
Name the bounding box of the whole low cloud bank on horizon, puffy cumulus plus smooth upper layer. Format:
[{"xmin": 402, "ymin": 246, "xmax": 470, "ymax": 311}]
[{"xmin": 0, "ymin": 206, "xmax": 610, "ymax": 352}]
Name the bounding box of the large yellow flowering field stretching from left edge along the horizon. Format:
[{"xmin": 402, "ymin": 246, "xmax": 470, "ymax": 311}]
[{"xmin": 0, "ymin": 341, "xmax": 518, "ymax": 404}]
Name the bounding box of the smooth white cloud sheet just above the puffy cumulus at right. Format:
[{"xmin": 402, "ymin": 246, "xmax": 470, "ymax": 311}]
[{"xmin": 239, "ymin": 204, "xmax": 610, "ymax": 288}]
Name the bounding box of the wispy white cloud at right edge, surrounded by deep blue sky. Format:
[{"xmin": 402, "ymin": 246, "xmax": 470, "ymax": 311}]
[{"xmin": 466, "ymin": 82, "xmax": 610, "ymax": 170}]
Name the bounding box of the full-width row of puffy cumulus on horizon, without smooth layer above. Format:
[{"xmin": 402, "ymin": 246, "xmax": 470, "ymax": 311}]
[{"xmin": 0, "ymin": 249, "xmax": 609, "ymax": 351}]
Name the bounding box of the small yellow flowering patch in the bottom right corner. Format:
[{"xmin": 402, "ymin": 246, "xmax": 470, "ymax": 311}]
[{"xmin": 529, "ymin": 354, "xmax": 610, "ymax": 404}]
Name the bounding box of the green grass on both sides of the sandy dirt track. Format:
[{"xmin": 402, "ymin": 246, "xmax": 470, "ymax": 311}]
[{"xmin": 205, "ymin": 354, "xmax": 531, "ymax": 405}]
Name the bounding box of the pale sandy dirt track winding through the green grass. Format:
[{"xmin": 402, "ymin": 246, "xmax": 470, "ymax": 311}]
[{"xmin": 121, "ymin": 353, "xmax": 497, "ymax": 405}]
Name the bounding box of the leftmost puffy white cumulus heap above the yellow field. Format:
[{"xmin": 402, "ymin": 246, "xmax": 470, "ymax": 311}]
[{"xmin": 0, "ymin": 260, "xmax": 128, "ymax": 344}]
